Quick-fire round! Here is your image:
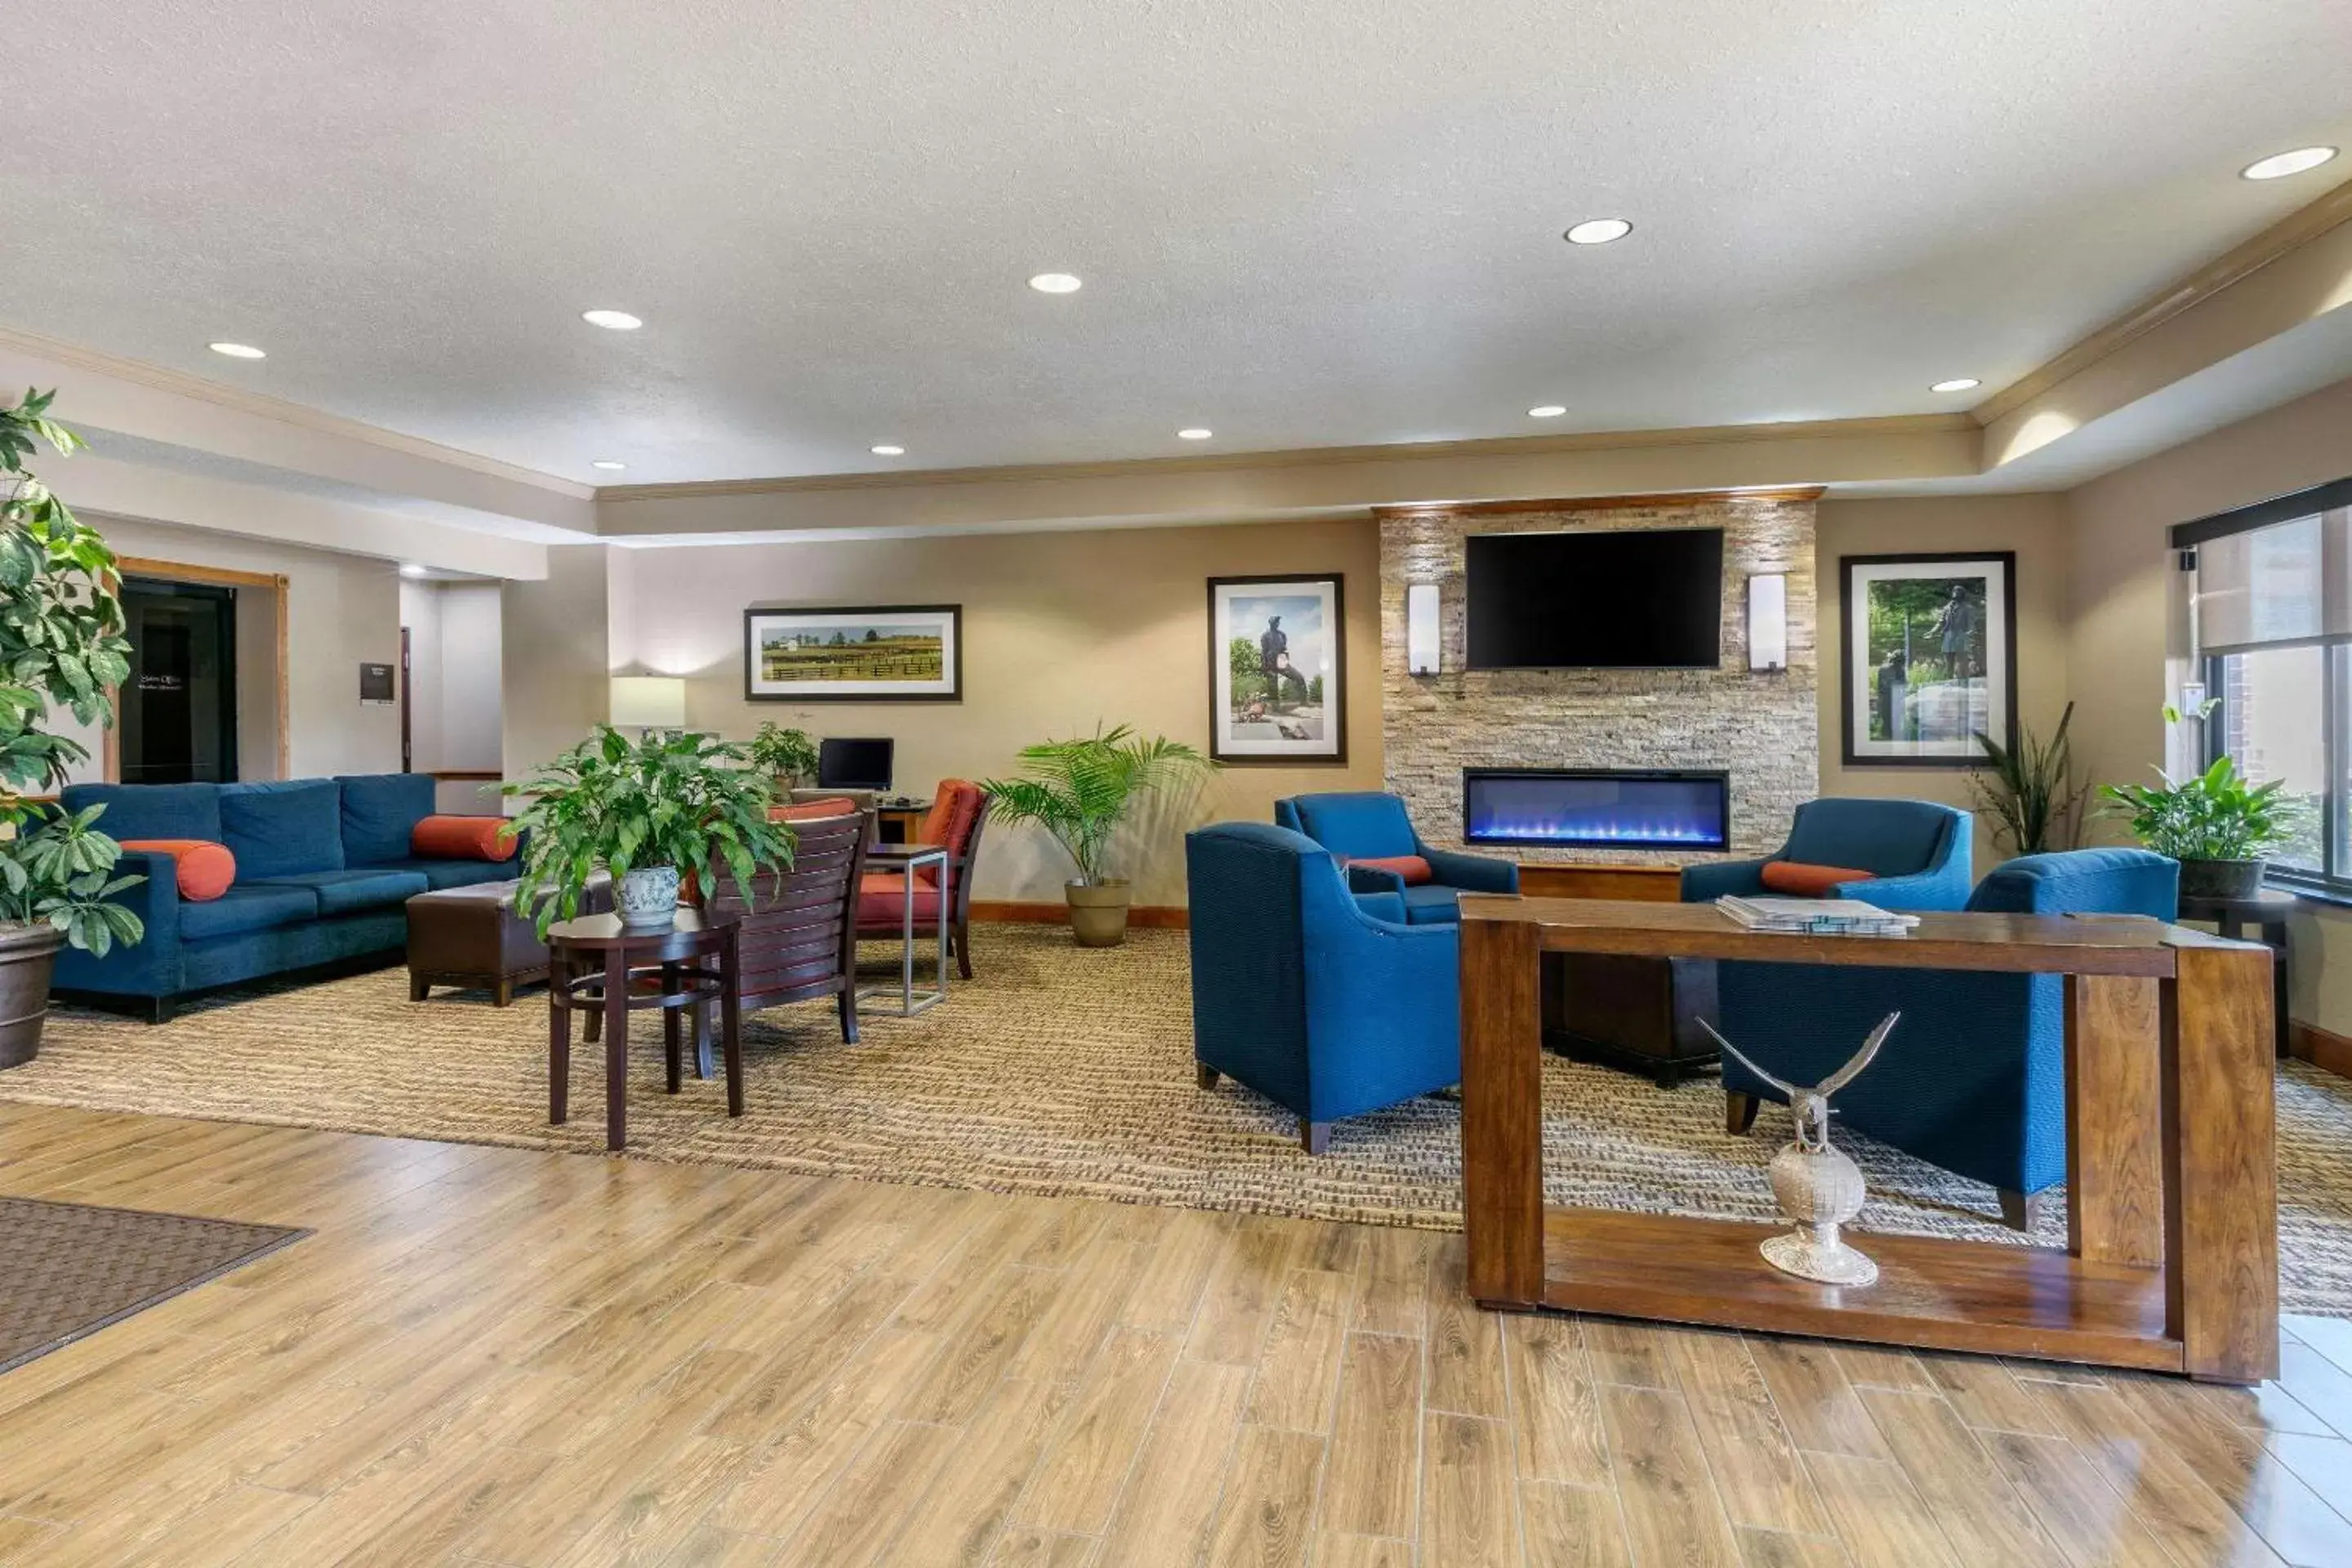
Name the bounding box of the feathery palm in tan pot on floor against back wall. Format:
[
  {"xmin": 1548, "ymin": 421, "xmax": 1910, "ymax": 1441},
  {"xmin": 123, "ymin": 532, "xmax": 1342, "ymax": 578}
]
[{"xmin": 981, "ymin": 724, "xmax": 1216, "ymax": 947}]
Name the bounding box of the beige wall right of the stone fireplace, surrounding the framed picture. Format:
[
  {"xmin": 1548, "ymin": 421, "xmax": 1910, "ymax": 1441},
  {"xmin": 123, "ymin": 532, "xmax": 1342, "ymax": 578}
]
[{"xmin": 1815, "ymin": 496, "xmax": 2098, "ymax": 870}]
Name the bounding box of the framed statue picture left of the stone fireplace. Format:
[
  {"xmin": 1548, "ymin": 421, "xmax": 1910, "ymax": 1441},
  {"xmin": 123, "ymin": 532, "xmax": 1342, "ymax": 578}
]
[{"xmin": 1209, "ymin": 571, "xmax": 1348, "ymax": 766}]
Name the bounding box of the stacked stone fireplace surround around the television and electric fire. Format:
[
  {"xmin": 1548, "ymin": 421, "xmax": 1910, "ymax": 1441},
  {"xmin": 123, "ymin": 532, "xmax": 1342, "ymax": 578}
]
[{"xmin": 1376, "ymin": 492, "xmax": 1820, "ymax": 865}]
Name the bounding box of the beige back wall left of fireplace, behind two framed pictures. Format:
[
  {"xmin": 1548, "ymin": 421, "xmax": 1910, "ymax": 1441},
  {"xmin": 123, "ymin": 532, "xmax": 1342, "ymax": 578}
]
[{"xmin": 592, "ymin": 519, "xmax": 1381, "ymax": 905}]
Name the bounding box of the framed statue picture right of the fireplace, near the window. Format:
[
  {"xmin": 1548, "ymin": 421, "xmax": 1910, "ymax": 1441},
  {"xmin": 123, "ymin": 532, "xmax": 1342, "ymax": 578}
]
[{"xmin": 1837, "ymin": 550, "xmax": 2018, "ymax": 768}]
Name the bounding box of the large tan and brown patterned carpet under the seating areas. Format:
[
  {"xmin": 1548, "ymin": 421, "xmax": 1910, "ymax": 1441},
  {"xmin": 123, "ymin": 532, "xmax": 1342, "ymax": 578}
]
[{"xmin": 0, "ymin": 926, "xmax": 2352, "ymax": 1314}]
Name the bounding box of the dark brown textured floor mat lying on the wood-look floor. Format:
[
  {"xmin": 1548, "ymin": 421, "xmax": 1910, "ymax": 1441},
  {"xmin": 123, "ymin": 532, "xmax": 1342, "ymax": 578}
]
[{"xmin": 0, "ymin": 1199, "xmax": 310, "ymax": 1373}]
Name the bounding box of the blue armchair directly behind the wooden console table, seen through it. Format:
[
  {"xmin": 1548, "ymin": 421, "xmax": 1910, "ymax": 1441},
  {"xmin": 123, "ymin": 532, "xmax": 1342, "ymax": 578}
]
[{"xmin": 1717, "ymin": 849, "xmax": 2180, "ymax": 1229}]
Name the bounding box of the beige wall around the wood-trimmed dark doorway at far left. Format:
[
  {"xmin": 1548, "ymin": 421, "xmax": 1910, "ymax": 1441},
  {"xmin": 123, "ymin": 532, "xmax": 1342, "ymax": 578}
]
[{"xmin": 82, "ymin": 513, "xmax": 400, "ymax": 778}]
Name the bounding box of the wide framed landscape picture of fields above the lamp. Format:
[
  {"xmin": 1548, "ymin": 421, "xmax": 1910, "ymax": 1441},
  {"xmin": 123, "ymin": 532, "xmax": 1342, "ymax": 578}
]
[{"xmin": 743, "ymin": 604, "xmax": 964, "ymax": 703}]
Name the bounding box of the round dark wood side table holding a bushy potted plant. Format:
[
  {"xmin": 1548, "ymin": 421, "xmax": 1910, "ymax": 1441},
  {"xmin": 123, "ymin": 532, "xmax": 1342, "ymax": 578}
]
[{"xmin": 548, "ymin": 907, "xmax": 743, "ymax": 1152}]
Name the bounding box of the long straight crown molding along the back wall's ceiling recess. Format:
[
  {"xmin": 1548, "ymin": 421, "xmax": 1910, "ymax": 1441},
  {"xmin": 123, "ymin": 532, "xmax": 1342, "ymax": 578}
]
[{"xmin": 595, "ymin": 414, "xmax": 1978, "ymax": 501}]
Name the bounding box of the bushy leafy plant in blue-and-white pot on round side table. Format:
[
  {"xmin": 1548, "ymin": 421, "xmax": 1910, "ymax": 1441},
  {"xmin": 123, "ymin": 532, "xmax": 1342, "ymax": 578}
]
[{"xmin": 503, "ymin": 724, "xmax": 793, "ymax": 936}]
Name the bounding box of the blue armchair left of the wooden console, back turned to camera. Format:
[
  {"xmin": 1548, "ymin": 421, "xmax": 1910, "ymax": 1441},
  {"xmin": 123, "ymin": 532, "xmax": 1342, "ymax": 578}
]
[{"xmin": 1186, "ymin": 822, "xmax": 1463, "ymax": 1154}]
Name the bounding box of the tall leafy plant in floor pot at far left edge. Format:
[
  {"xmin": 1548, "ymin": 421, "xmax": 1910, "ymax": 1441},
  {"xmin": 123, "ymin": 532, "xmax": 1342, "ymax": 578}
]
[{"xmin": 0, "ymin": 390, "xmax": 146, "ymax": 1067}]
